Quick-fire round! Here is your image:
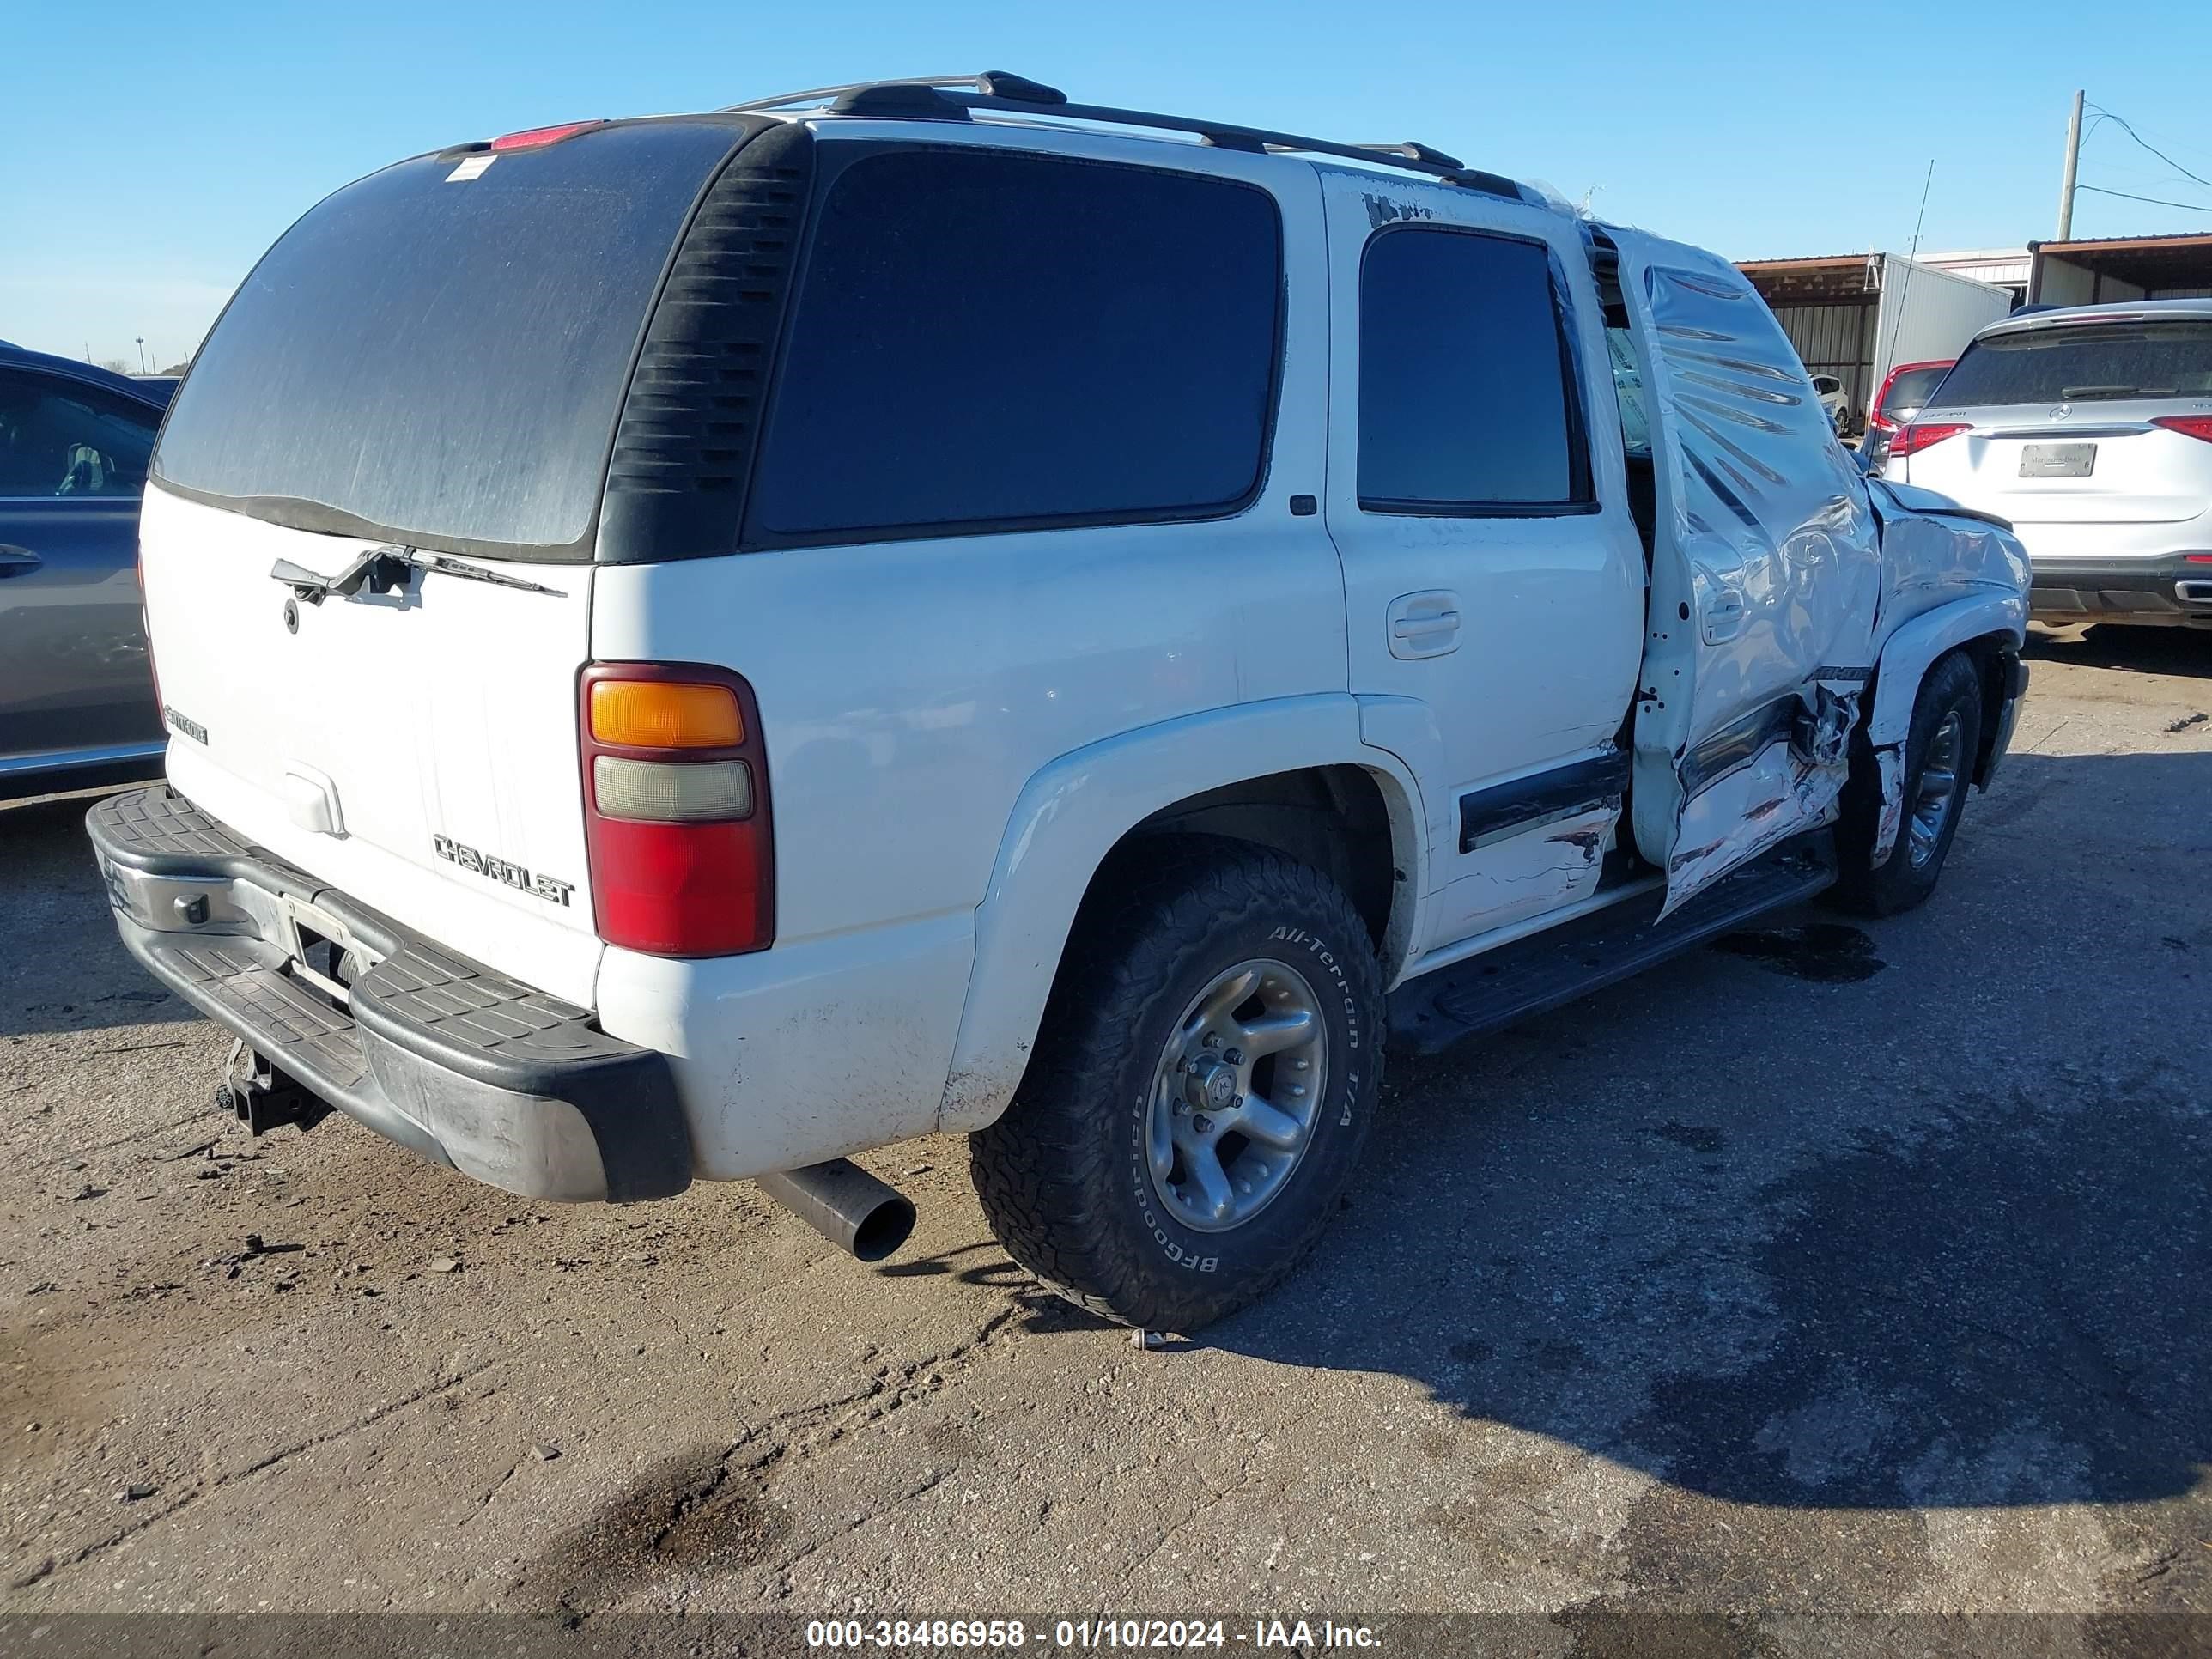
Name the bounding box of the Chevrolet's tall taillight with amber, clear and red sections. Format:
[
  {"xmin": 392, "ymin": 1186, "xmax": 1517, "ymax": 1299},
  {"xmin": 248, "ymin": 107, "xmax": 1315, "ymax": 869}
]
[{"xmin": 577, "ymin": 664, "xmax": 776, "ymax": 956}]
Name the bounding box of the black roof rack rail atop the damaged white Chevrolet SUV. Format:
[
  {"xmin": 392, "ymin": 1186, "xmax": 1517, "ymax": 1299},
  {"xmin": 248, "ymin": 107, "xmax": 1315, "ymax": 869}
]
[{"xmin": 728, "ymin": 69, "xmax": 1531, "ymax": 201}]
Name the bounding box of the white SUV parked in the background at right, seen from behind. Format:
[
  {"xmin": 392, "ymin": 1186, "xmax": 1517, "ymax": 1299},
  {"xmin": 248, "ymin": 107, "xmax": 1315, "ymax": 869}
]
[{"xmin": 1885, "ymin": 299, "xmax": 2212, "ymax": 629}]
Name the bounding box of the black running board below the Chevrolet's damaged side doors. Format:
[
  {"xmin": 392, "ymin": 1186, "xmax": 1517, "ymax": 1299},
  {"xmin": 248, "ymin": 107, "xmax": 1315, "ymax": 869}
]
[{"xmin": 1389, "ymin": 832, "xmax": 1836, "ymax": 1055}]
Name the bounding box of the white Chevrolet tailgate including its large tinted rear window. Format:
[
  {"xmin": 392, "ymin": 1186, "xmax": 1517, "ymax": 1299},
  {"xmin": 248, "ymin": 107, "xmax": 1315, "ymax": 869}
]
[{"xmin": 143, "ymin": 118, "xmax": 748, "ymax": 1005}]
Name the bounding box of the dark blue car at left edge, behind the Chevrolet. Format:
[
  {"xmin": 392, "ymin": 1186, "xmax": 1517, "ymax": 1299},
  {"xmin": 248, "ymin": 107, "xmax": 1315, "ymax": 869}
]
[{"xmin": 0, "ymin": 343, "xmax": 177, "ymax": 801}]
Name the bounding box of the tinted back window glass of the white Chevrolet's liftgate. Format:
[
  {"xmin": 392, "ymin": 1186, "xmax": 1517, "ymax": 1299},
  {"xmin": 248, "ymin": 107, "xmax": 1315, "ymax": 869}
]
[{"xmin": 155, "ymin": 122, "xmax": 738, "ymax": 557}]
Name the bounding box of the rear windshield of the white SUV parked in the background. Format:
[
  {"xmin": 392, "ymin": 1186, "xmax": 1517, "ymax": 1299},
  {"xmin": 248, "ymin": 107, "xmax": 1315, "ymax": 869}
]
[{"xmin": 1924, "ymin": 321, "xmax": 2212, "ymax": 410}]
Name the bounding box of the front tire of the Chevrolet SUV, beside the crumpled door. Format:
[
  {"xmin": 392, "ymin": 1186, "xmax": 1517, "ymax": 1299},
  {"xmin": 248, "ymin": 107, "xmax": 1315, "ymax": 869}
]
[{"xmin": 1829, "ymin": 653, "xmax": 1982, "ymax": 915}]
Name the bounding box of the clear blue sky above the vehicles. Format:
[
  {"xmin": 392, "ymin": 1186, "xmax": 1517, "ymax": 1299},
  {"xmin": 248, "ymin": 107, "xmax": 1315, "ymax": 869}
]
[{"xmin": 0, "ymin": 0, "xmax": 2212, "ymax": 362}]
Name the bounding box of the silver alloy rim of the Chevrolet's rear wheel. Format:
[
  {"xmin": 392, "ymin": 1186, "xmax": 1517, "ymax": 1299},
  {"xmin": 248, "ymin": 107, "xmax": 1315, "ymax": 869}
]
[{"xmin": 1146, "ymin": 957, "xmax": 1329, "ymax": 1232}]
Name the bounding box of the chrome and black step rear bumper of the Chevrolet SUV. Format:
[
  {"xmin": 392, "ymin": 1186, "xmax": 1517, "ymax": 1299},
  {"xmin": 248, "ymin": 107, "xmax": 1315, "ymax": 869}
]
[{"xmin": 86, "ymin": 787, "xmax": 692, "ymax": 1201}]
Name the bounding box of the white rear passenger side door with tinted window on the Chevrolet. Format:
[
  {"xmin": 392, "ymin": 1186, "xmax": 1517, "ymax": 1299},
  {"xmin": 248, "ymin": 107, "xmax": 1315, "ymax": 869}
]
[{"xmin": 1321, "ymin": 168, "xmax": 1644, "ymax": 949}]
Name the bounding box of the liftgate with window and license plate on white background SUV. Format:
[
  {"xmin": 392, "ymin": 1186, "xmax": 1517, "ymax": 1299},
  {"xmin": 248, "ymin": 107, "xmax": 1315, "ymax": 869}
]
[{"xmin": 1891, "ymin": 312, "xmax": 2212, "ymax": 535}]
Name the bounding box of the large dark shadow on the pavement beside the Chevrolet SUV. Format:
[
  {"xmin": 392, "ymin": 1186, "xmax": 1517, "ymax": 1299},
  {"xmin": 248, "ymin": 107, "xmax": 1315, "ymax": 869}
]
[{"xmin": 1201, "ymin": 751, "xmax": 2212, "ymax": 1509}]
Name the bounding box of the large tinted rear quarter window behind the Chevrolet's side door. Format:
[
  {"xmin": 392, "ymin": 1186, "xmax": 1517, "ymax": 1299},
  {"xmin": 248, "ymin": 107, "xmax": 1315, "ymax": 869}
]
[{"xmin": 748, "ymin": 150, "xmax": 1283, "ymax": 544}]
